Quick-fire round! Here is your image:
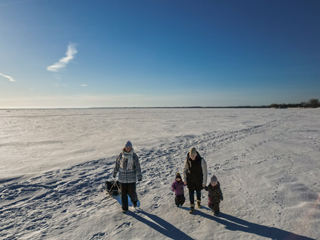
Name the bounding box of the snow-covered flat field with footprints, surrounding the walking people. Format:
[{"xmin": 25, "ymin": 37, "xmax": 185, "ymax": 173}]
[{"xmin": 0, "ymin": 109, "xmax": 320, "ymax": 240}]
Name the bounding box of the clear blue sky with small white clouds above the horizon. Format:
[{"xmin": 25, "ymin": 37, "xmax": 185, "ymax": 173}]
[{"xmin": 0, "ymin": 0, "xmax": 320, "ymax": 108}]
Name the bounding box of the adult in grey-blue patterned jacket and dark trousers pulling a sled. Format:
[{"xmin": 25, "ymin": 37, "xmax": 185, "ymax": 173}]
[{"xmin": 113, "ymin": 141, "xmax": 142, "ymax": 213}]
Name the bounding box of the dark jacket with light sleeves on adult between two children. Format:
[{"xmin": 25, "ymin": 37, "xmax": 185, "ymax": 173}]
[{"xmin": 183, "ymin": 152, "xmax": 207, "ymax": 190}]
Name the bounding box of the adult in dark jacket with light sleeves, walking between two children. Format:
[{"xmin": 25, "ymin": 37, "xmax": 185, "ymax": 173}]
[{"xmin": 183, "ymin": 147, "xmax": 207, "ymax": 213}]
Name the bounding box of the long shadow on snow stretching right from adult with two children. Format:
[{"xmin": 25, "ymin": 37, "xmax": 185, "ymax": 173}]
[{"xmin": 195, "ymin": 211, "xmax": 315, "ymax": 240}]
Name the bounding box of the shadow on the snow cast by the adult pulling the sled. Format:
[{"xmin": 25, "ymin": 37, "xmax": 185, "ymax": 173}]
[{"xmin": 128, "ymin": 210, "xmax": 193, "ymax": 240}]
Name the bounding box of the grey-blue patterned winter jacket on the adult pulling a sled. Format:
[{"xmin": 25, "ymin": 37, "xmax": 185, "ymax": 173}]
[{"xmin": 113, "ymin": 149, "xmax": 142, "ymax": 183}]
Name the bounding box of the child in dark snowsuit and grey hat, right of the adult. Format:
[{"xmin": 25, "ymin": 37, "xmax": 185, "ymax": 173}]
[{"xmin": 205, "ymin": 175, "xmax": 223, "ymax": 216}]
